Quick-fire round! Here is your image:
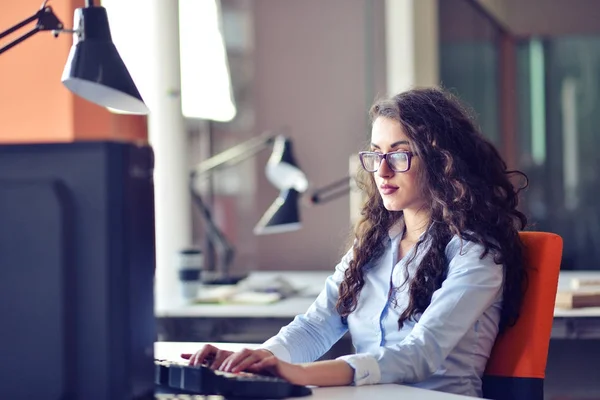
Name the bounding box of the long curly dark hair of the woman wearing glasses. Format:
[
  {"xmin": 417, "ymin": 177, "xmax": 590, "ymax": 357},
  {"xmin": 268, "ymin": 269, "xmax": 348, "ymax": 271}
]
[{"xmin": 336, "ymin": 88, "xmax": 527, "ymax": 332}]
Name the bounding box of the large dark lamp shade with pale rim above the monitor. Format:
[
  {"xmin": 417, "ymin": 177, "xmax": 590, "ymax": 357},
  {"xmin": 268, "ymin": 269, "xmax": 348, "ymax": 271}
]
[{"xmin": 62, "ymin": 6, "xmax": 149, "ymax": 114}]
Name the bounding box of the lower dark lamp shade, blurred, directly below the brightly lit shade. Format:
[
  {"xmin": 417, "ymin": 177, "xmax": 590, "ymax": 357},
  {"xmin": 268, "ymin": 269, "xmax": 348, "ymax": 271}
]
[{"xmin": 254, "ymin": 189, "xmax": 301, "ymax": 235}]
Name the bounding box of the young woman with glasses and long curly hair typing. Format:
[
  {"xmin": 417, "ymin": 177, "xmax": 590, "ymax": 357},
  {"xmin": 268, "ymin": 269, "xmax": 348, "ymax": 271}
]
[{"xmin": 182, "ymin": 89, "xmax": 527, "ymax": 396}]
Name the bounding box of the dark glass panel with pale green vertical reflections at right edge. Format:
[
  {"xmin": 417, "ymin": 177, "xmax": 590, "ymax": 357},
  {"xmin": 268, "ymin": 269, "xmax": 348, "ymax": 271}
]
[{"xmin": 517, "ymin": 36, "xmax": 600, "ymax": 269}]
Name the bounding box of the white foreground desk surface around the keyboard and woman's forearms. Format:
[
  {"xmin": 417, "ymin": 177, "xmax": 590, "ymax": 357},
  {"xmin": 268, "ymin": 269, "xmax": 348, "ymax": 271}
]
[{"xmin": 154, "ymin": 342, "xmax": 473, "ymax": 400}]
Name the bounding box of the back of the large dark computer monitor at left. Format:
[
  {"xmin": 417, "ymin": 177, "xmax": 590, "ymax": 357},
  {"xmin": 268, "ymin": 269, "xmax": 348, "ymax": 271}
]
[{"xmin": 0, "ymin": 142, "xmax": 156, "ymax": 400}]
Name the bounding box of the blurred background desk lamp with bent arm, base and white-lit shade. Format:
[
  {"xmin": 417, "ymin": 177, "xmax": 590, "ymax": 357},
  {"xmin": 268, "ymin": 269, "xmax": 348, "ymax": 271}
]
[{"xmin": 190, "ymin": 132, "xmax": 308, "ymax": 284}]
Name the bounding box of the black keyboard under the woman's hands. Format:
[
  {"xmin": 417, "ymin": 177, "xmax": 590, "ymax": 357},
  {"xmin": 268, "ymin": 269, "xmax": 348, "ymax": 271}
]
[{"xmin": 154, "ymin": 360, "xmax": 312, "ymax": 399}]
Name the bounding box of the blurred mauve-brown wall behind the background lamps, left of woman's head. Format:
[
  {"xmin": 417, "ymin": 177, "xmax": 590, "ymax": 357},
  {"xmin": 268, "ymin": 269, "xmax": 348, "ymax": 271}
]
[{"xmin": 253, "ymin": 0, "xmax": 385, "ymax": 270}]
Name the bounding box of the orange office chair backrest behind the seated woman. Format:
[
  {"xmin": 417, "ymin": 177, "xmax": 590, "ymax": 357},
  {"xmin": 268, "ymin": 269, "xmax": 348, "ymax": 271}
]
[{"xmin": 483, "ymin": 232, "xmax": 563, "ymax": 400}]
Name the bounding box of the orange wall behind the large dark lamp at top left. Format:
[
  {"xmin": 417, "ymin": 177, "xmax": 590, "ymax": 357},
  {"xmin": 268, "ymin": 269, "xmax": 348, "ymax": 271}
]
[{"xmin": 0, "ymin": 0, "xmax": 148, "ymax": 143}]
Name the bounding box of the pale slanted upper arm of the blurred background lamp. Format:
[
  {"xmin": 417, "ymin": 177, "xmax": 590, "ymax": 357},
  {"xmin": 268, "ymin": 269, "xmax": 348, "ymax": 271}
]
[{"xmin": 192, "ymin": 132, "xmax": 277, "ymax": 179}]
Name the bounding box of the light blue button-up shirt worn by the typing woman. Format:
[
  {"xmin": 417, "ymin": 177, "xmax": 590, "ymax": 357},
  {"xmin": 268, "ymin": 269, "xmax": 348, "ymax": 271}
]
[{"xmin": 262, "ymin": 224, "xmax": 503, "ymax": 397}]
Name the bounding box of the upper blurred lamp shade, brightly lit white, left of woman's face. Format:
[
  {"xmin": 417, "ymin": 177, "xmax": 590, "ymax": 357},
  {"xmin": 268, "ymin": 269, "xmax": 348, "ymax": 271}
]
[{"xmin": 265, "ymin": 135, "xmax": 308, "ymax": 193}]
